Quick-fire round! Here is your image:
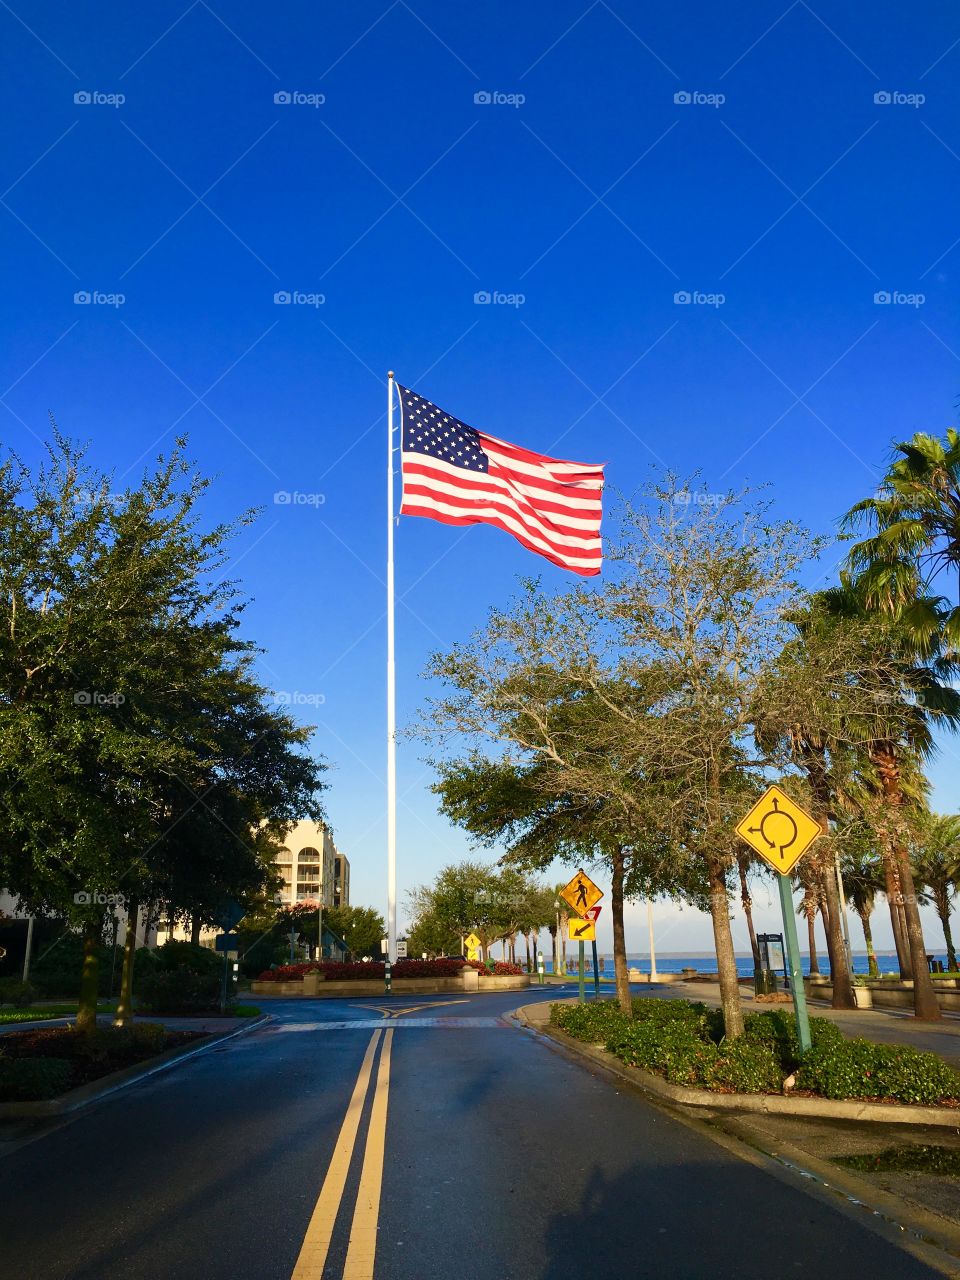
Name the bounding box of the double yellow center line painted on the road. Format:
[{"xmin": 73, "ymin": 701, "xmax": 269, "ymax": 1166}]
[{"xmin": 292, "ymin": 1028, "xmax": 393, "ymax": 1280}]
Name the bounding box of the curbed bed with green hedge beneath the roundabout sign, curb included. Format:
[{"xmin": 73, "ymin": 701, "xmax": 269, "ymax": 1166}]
[{"xmin": 531, "ymin": 997, "xmax": 960, "ymax": 1128}]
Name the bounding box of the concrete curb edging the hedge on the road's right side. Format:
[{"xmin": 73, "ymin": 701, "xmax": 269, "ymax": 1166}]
[{"xmin": 515, "ymin": 1006, "xmax": 960, "ymax": 1129}]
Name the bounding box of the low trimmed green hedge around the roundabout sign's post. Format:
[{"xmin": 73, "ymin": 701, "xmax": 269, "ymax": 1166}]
[{"xmin": 550, "ymin": 996, "xmax": 960, "ymax": 1106}]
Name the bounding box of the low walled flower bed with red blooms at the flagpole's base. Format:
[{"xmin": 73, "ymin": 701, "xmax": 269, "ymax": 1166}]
[{"xmin": 251, "ymin": 959, "xmax": 530, "ymax": 998}]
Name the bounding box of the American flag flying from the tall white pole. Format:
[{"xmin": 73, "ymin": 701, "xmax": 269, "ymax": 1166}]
[{"xmin": 397, "ymin": 383, "xmax": 603, "ymax": 577}]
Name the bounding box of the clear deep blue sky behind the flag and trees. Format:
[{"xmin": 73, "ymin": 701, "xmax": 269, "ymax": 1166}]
[{"xmin": 0, "ymin": 0, "xmax": 960, "ymax": 950}]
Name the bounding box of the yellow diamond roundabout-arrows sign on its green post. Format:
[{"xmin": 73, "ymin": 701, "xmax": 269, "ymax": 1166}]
[{"xmin": 736, "ymin": 786, "xmax": 823, "ymax": 1053}]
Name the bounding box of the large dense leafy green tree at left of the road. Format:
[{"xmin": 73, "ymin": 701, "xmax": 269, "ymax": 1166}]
[{"xmin": 0, "ymin": 430, "xmax": 320, "ymax": 1030}]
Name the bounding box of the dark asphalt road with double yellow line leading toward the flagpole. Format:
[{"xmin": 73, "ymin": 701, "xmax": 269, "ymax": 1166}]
[{"xmin": 0, "ymin": 989, "xmax": 940, "ymax": 1280}]
